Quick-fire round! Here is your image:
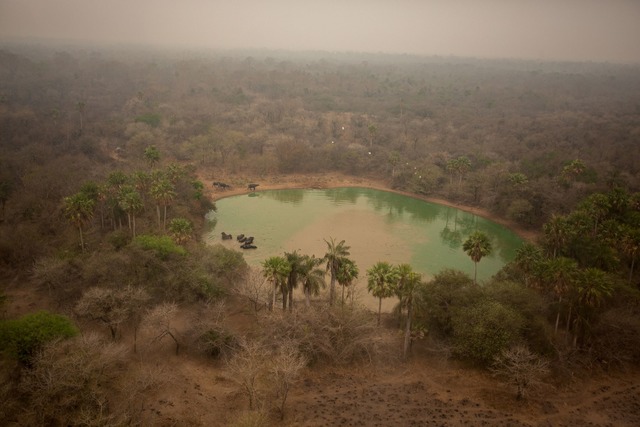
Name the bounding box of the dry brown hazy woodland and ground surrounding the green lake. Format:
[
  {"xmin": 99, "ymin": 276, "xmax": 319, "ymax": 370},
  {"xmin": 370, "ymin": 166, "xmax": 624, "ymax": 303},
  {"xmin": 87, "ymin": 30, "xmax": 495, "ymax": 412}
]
[{"xmin": 0, "ymin": 44, "xmax": 640, "ymax": 426}]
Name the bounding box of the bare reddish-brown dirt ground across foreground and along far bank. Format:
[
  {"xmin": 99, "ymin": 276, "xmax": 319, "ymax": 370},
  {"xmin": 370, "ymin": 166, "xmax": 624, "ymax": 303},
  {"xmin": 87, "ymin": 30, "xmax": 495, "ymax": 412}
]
[{"xmin": 4, "ymin": 175, "xmax": 640, "ymax": 427}]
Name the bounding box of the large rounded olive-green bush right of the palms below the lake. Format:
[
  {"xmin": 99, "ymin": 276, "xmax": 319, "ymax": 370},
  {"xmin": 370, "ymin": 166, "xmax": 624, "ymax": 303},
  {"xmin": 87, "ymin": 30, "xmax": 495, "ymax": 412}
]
[{"xmin": 453, "ymin": 300, "xmax": 523, "ymax": 366}]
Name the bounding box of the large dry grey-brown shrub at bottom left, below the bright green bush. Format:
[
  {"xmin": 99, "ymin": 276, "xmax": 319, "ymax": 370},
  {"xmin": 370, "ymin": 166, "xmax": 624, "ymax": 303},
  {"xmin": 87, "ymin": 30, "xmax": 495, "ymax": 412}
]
[{"xmin": 20, "ymin": 334, "xmax": 128, "ymax": 426}]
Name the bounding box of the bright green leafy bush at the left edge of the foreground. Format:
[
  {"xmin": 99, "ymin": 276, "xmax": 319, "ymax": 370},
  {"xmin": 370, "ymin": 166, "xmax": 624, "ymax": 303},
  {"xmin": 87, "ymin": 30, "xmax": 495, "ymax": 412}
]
[{"xmin": 0, "ymin": 311, "xmax": 78, "ymax": 363}]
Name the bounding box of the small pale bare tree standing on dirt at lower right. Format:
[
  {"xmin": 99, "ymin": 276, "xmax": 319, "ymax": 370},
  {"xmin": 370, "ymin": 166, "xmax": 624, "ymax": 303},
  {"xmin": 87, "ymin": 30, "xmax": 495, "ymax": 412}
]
[{"xmin": 491, "ymin": 345, "xmax": 549, "ymax": 400}]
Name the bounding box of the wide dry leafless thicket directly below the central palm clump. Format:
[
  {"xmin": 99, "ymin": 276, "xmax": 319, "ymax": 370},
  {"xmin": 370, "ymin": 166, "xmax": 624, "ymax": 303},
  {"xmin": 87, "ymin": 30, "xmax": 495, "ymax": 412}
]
[{"xmin": 264, "ymin": 305, "xmax": 381, "ymax": 364}]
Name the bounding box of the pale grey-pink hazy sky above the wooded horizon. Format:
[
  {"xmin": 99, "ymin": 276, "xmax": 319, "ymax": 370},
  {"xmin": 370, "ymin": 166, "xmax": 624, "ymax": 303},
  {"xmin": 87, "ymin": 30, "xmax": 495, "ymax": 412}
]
[{"xmin": 0, "ymin": 0, "xmax": 640, "ymax": 63}]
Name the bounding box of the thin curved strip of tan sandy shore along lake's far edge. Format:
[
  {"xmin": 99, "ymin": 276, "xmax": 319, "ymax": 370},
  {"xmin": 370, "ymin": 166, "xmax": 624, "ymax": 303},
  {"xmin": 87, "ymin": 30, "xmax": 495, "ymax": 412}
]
[{"xmin": 199, "ymin": 172, "xmax": 539, "ymax": 241}]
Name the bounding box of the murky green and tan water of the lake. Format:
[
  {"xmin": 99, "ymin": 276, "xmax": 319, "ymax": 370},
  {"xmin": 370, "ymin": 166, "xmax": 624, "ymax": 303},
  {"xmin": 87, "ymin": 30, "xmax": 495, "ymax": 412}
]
[{"xmin": 206, "ymin": 187, "xmax": 522, "ymax": 310}]
